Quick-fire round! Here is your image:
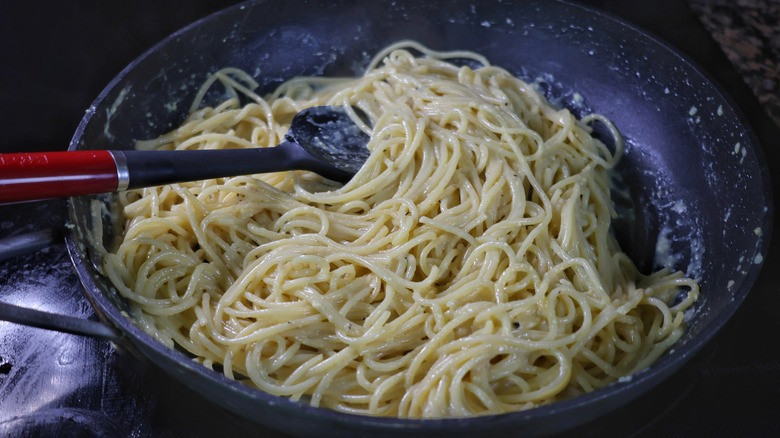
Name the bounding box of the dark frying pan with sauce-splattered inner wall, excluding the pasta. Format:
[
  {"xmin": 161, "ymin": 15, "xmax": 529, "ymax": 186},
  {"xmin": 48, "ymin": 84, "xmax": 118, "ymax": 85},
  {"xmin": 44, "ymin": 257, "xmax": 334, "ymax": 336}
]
[{"xmin": 12, "ymin": 0, "xmax": 772, "ymax": 436}]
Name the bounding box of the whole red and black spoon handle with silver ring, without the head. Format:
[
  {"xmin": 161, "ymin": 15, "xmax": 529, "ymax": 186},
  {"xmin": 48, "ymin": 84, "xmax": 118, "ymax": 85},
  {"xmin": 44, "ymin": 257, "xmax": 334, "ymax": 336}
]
[{"xmin": 0, "ymin": 142, "xmax": 300, "ymax": 204}]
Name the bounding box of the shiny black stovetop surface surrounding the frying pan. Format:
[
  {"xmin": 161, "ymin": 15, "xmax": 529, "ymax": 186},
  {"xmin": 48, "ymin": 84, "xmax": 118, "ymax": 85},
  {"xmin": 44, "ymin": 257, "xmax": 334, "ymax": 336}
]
[{"xmin": 0, "ymin": 0, "xmax": 780, "ymax": 437}]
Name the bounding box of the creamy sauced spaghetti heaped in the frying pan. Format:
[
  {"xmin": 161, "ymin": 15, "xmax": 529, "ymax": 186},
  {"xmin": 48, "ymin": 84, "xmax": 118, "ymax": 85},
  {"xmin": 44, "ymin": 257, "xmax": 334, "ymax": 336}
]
[{"xmin": 104, "ymin": 42, "xmax": 698, "ymax": 418}]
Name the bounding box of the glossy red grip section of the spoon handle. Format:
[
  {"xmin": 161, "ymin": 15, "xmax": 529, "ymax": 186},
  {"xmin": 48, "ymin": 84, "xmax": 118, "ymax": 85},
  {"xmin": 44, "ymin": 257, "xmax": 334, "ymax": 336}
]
[{"xmin": 0, "ymin": 151, "xmax": 118, "ymax": 203}]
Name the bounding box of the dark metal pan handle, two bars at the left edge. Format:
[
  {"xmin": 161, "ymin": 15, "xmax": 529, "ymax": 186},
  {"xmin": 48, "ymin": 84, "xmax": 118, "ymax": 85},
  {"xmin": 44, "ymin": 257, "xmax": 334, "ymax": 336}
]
[{"xmin": 0, "ymin": 230, "xmax": 122, "ymax": 341}]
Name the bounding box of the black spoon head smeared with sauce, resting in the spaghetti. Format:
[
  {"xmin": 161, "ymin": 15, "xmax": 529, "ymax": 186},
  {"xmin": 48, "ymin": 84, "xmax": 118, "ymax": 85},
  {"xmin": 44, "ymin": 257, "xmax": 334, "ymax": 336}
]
[{"xmin": 287, "ymin": 106, "xmax": 370, "ymax": 180}]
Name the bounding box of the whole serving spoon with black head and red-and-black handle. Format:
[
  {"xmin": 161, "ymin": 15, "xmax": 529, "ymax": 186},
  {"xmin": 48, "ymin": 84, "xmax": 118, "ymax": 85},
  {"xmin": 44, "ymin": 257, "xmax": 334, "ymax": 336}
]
[{"xmin": 0, "ymin": 106, "xmax": 369, "ymax": 203}]
